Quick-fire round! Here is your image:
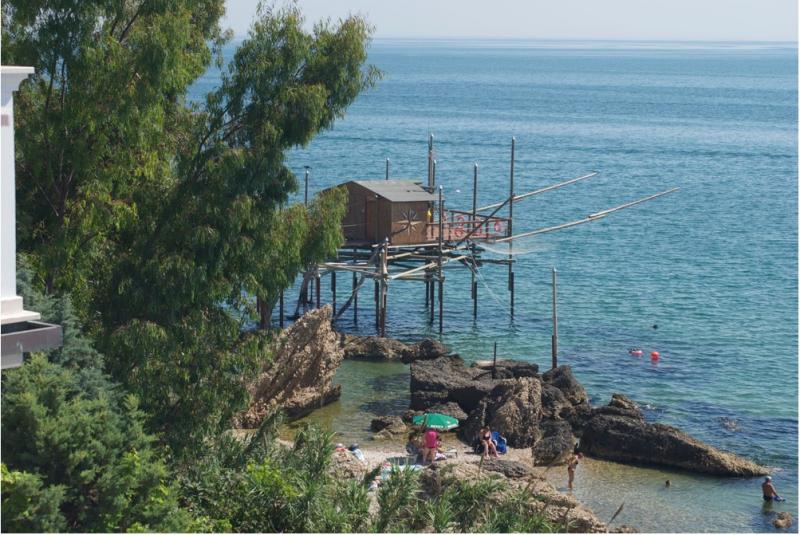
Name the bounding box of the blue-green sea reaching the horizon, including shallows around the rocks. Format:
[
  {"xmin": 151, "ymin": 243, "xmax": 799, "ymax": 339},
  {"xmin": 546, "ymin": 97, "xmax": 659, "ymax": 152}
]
[{"xmin": 192, "ymin": 39, "xmax": 798, "ymax": 532}]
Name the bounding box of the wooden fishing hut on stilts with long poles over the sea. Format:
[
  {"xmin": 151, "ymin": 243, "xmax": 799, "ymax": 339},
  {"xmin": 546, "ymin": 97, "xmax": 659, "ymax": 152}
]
[{"xmin": 288, "ymin": 136, "xmax": 677, "ymax": 342}]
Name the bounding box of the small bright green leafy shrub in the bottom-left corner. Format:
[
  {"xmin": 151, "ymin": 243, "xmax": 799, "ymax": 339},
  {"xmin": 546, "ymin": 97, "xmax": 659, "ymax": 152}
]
[{"xmin": 0, "ymin": 464, "xmax": 66, "ymax": 533}]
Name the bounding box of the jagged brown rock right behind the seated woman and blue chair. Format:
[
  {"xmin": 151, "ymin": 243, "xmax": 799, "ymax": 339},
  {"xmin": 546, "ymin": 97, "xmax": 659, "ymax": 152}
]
[{"xmin": 461, "ymin": 377, "xmax": 542, "ymax": 448}]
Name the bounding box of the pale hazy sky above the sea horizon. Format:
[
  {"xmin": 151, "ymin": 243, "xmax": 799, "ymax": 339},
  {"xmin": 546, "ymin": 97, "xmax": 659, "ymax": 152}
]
[{"xmin": 223, "ymin": 0, "xmax": 797, "ymax": 41}]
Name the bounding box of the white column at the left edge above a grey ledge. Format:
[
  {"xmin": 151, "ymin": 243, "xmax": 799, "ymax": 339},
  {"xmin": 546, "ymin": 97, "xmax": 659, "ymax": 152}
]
[{"xmin": 0, "ymin": 66, "xmax": 40, "ymax": 324}]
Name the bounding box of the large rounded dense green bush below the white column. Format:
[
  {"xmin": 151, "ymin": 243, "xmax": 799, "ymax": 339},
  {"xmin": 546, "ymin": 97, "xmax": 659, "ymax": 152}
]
[{"xmin": 2, "ymin": 355, "xmax": 200, "ymax": 531}]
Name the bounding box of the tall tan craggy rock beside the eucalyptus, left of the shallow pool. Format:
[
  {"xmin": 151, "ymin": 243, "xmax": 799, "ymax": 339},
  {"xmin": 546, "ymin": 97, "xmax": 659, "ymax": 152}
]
[{"xmin": 233, "ymin": 306, "xmax": 344, "ymax": 428}]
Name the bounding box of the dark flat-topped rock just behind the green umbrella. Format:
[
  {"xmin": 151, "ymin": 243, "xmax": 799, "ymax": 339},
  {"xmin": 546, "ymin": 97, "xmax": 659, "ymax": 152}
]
[{"xmin": 411, "ymin": 355, "xmax": 495, "ymax": 413}]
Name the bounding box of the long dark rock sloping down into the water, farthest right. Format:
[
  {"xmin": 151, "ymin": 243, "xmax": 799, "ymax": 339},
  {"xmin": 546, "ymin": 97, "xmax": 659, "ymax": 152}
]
[{"xmin": 580, "ymin": 395, "xmax": 768, "ymax": 477}]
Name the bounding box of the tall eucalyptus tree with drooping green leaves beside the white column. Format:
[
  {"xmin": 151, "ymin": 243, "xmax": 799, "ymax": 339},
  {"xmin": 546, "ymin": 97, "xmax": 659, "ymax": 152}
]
[{"xmin": 2, "ymin": 0, "xmax": 379, "ymax": 449}]
